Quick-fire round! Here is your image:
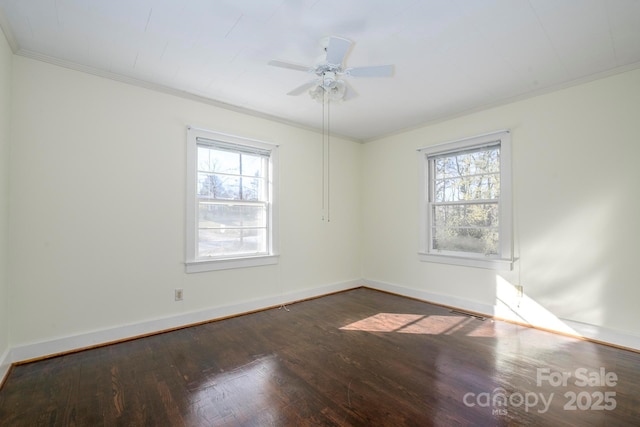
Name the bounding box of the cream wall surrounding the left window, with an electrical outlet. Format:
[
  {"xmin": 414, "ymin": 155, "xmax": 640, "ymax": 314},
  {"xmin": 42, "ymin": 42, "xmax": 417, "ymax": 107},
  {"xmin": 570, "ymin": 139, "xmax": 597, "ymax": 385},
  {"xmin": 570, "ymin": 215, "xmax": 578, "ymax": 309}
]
[{"xmin": 10, "ymin": 57, "xmax": 362, "ymax": 347}]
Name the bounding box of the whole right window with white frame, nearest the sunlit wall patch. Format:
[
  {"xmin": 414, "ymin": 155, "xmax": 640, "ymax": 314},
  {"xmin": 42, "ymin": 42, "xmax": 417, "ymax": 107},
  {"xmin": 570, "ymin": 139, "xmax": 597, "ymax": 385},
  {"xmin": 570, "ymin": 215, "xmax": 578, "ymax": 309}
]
[{"xmin": 418, "ymin": 131, "xmax": 513, "ymax": 269}]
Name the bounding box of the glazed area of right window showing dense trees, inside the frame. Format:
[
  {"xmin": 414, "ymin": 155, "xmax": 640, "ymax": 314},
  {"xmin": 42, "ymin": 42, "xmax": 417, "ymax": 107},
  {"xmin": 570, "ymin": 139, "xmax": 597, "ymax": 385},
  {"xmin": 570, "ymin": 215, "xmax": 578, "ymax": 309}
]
[{"xmin": 429, "ymin": 145, "xmax": 500, "ymax": 255}]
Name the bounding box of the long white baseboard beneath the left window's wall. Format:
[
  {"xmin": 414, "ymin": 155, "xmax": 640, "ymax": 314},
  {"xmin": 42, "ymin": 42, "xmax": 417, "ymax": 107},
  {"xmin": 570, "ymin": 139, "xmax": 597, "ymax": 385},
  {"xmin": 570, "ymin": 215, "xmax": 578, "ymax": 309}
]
[{"xmin": 8, "ymin": 280, "xmax": 362, "ymax": 364}]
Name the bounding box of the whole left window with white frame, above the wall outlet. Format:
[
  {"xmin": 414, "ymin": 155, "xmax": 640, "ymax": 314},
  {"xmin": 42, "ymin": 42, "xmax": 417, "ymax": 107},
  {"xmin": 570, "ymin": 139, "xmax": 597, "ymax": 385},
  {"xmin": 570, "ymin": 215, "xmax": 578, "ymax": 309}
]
[{"xmin": 186, "ymin": 128, "xmax": 277, "ymax": 272}]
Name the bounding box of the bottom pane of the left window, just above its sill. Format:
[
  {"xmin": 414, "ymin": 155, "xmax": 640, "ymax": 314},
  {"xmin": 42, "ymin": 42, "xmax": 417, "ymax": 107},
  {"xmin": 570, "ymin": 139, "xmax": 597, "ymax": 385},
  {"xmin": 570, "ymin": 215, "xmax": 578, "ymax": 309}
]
[{"xmin": 198, "ymin": 228, "xmax": 267, "ymax": 257}]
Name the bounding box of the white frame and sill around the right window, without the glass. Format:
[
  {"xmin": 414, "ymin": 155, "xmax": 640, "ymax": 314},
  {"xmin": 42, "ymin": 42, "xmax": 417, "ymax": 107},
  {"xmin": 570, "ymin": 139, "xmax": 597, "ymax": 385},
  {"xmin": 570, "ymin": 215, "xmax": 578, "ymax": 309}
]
[{"xmin": 417, "ymin": 130, "xmax": 514, "ymax": 270}]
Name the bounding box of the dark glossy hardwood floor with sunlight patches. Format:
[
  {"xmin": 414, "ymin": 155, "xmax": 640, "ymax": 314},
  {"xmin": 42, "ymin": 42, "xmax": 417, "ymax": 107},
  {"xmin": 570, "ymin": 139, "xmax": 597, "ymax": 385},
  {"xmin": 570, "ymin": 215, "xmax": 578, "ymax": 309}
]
[{"xmin": 0, "ymin": 288, "xmax": 640, "ymax": 426}]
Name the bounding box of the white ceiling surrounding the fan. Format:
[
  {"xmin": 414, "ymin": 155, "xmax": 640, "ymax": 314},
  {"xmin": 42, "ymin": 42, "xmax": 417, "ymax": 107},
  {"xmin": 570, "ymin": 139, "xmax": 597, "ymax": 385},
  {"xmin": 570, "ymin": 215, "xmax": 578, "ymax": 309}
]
[{"xmin": 0, "ymin": 0, "xmax": 640, "ymax": 141}]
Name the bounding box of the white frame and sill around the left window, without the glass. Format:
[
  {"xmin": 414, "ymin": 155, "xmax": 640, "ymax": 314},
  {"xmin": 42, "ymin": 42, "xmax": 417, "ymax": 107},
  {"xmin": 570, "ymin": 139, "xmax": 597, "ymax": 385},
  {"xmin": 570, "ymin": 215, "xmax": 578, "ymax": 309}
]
[{"xmin": 185, "ymin": 126, "xmax": 279, "ymax": 273}]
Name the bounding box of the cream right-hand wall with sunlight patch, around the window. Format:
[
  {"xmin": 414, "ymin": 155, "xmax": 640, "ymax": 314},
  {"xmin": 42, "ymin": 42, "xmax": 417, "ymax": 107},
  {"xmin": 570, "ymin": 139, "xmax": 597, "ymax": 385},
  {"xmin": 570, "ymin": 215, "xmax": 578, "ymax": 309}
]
[{"xmin": 362, "ymin": 70, "xmax": 640, "ymax": 342}]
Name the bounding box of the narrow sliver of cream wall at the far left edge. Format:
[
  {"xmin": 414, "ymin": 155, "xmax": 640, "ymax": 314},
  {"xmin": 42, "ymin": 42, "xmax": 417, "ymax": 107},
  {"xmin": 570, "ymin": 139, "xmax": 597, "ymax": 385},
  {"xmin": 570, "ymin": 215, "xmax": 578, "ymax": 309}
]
[{"xmin": 0, "ymin": 25, "xmax": 13, "ymax": 372}]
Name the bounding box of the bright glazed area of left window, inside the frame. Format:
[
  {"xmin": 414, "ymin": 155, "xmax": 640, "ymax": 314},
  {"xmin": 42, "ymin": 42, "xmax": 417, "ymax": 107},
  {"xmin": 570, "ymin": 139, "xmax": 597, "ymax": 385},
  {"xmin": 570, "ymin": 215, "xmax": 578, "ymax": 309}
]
[{"xmin": 197, "ymin": 144, "xmax": 269, "ymax": 257}]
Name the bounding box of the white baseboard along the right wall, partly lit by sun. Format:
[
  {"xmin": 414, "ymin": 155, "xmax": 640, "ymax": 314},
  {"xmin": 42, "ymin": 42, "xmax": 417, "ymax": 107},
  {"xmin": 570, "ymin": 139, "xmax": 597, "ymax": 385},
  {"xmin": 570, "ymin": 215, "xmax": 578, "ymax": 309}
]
[{"xmin": 362, "ymin": 279, "xmax": 640, "ymax": 351}]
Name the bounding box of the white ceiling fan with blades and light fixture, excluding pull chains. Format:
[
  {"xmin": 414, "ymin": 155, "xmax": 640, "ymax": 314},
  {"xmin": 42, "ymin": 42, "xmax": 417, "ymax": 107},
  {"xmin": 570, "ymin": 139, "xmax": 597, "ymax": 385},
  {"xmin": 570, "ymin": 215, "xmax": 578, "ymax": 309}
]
[{"xmin": 268, "ymin": 36, "xmax": 393, "ymax": 102}]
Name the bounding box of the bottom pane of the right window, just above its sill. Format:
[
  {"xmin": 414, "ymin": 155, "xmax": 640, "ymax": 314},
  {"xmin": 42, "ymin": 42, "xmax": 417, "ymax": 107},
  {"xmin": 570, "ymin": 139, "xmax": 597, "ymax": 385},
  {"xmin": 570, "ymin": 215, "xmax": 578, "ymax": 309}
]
[{"xmin": 433, "ymin": 227, "xmax": 498, "ymax": 255}]
